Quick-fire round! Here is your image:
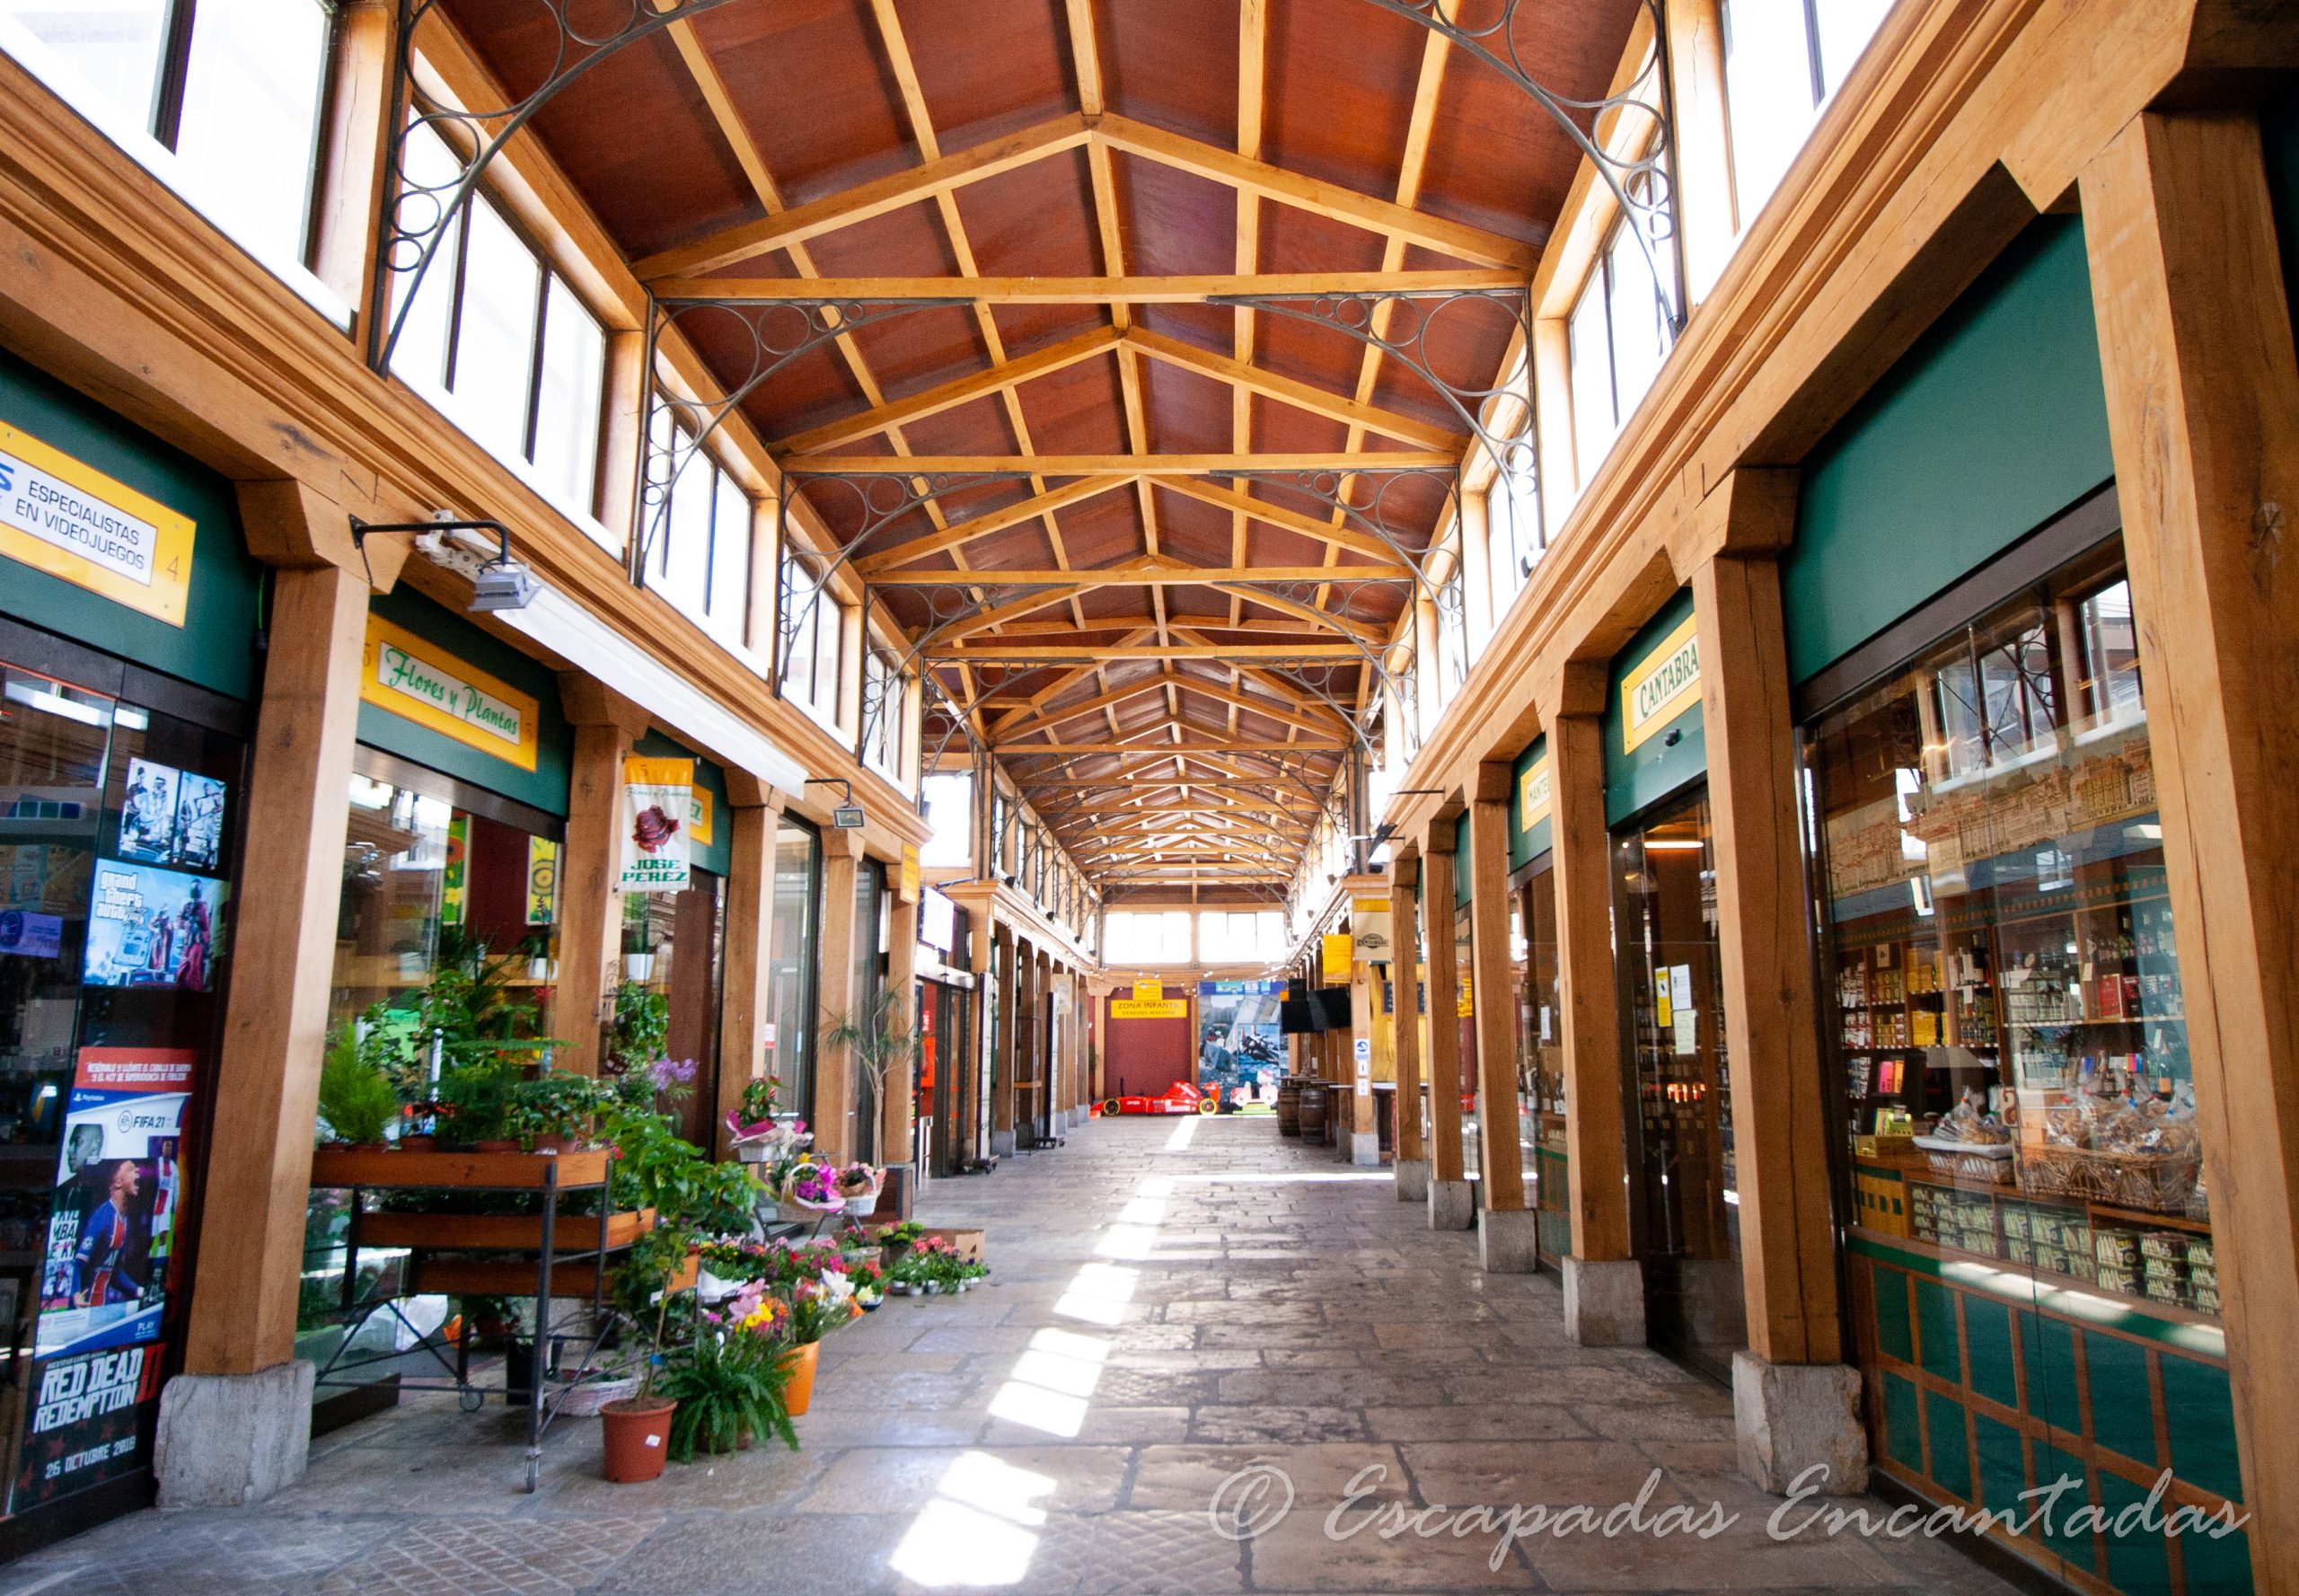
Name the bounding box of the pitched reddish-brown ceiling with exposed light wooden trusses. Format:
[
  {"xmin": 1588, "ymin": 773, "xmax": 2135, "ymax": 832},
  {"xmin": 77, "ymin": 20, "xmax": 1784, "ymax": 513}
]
[{"xmin": 444, "ymin": 0, "xmax": 1639, "ymax": 902}]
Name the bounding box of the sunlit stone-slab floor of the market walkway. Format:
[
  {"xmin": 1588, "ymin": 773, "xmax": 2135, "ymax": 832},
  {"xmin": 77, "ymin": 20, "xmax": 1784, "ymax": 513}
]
[{"xmin": 0, "ymin": 1117, "xmax": 2041, "ymax": 1596}]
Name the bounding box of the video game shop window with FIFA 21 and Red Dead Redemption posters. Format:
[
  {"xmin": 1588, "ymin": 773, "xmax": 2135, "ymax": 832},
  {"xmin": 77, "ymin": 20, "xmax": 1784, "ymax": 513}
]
[{"xmin": 0, "ymin": 641, "xmax": 246, "ymax": 1548}]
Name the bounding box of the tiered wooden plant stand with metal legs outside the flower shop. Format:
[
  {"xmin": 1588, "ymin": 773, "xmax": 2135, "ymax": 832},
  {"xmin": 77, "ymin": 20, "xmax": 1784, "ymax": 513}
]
[{"xmin": 296, "ymin": 1148, "xmax": 675, "ymax": 1490}]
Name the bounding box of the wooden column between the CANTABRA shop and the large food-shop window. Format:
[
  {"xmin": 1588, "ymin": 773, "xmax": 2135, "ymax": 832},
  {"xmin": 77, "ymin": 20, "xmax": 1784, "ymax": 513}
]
[{"xmin": 1692, "ymin": 544, "xmax": 1844, "ymax": 1363}]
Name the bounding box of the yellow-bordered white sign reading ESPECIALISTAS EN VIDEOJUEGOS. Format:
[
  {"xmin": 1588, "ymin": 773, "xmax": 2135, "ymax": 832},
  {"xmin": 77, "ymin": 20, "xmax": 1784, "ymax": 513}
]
[{"xmin": 0, "ymin": 423, "xmax": 196, "ymax": 625}]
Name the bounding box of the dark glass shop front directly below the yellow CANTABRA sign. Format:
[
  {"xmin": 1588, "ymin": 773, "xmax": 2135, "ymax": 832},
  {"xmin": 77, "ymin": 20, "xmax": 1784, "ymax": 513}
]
[{"xmin": 1612, "ymin": 787, "xmax": 1748, "ymax": 1380}]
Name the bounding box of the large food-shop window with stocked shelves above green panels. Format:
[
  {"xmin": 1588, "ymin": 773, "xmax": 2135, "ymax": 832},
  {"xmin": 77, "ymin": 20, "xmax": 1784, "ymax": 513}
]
[{"xmin": 1805, "ymin": 541, "xmax": 2251, "ymax": 1593}]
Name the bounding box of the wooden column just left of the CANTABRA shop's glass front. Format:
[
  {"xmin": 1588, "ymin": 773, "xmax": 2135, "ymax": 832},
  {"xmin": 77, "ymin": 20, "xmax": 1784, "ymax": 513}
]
[{"xmin": 1543, "ymin": 690, "xmax": 1630, "ymax": 1263}]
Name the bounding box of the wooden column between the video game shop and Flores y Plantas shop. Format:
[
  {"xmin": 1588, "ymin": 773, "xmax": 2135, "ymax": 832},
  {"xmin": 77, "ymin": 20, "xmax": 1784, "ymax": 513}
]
[{"xmin": 184, "ymin": 566, "xmax": 368, "ymax": 1375}]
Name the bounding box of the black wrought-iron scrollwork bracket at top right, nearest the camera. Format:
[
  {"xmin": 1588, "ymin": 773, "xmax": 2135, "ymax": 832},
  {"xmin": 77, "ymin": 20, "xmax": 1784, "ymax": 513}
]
[{"xmin": 1368, "ymin": 0, "xmax": 1685, "ymax": 333}]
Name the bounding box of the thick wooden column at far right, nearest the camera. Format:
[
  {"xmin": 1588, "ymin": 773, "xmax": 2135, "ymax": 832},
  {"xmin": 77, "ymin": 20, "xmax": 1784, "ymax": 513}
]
[{"xmin": 2081, "ymin": 115, "xmax": 2299, "ymax": 1596}]
